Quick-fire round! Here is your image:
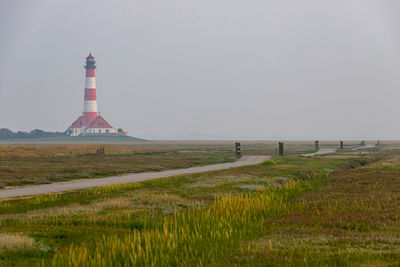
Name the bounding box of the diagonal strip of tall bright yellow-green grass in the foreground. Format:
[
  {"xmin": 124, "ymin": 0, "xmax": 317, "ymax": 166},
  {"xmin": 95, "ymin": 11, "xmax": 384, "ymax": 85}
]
[{"xmin": 52, "ymin": 181, "xmax": 322, "ymax": 266}]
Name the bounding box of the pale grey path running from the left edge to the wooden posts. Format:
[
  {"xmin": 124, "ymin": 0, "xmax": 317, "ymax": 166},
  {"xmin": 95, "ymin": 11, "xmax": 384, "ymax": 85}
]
[{"xmin": 0, "ymin": 156, "xmax": 271, "ymax": 199}]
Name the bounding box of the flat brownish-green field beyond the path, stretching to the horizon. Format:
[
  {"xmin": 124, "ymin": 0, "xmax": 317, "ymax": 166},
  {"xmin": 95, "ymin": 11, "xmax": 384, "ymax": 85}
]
[{"xmin": 0, "ymin": 142, "xmax": 322, "ymax": 188}]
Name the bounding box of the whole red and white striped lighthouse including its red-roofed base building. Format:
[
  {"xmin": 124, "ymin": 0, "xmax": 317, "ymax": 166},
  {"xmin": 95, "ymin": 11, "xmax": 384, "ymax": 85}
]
[{"xmin": 66, "ymin": 53, "xmax": 118, "ymax": 136}]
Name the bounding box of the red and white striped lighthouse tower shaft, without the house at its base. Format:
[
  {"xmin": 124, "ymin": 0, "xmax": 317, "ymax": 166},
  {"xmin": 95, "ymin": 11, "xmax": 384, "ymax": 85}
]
[{"xmin": 83, "ymin": 53, "xmax": 97, "ymax": 127}]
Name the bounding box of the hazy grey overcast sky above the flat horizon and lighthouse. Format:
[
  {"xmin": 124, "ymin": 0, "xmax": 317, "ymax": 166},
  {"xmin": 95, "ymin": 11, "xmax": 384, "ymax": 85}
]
[{"xmin": 0, "ymin": 0, "xmax": 400, "ymax": 140}]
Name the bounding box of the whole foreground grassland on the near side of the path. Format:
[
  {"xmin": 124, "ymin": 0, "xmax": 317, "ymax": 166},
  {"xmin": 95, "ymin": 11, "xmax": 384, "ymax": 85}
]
[{"xmin": 0, "ymin": 142, "xmax": 400, "ymax": 266}]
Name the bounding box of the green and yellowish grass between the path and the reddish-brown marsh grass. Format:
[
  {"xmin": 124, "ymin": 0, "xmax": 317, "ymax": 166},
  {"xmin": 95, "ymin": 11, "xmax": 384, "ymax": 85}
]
[{"xmin": 0, "ymin": 152, "xmax": 366, "ymax": 266}]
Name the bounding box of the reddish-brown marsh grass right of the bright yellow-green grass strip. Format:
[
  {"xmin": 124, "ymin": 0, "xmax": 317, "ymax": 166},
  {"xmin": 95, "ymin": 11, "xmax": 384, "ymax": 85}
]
[{"xmin": 232, "ymin": 151, "xmax": 400, "ymax": 266}]
